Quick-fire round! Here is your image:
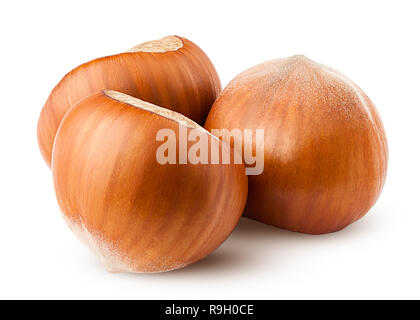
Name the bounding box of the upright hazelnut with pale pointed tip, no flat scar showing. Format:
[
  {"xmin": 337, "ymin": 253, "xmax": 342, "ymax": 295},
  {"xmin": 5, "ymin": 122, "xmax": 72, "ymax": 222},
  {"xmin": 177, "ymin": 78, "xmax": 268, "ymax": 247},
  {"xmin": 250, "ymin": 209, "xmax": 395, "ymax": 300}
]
[{"xmin": 205, "ymin": 56, "xmax": 388, "ymax": 234}]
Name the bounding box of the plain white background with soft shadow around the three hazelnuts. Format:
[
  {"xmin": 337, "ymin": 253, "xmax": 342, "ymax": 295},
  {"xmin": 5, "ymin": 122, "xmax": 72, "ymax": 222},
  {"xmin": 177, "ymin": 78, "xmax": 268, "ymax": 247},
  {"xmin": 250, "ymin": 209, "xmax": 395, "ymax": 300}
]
[{"xmin": 0, "ymin": 0, "xmax": 420, "ymax": 299}]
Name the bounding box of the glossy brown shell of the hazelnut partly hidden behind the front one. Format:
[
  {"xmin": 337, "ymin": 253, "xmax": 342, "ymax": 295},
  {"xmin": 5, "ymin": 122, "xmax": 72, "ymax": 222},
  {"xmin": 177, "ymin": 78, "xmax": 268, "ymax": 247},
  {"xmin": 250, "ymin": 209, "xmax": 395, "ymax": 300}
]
[{"xmin": 38, "ymin": 37, "xmax": 221, "ymax": 166}]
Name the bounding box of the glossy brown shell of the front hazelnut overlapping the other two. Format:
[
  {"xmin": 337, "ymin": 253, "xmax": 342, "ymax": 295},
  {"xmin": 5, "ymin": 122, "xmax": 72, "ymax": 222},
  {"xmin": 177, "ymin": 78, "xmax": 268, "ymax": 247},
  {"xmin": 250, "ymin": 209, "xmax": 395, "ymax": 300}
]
[{"xmin": 52, "ymin": 92, "xmax": 248, "ymax": 272}]
